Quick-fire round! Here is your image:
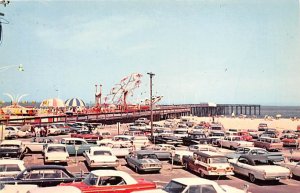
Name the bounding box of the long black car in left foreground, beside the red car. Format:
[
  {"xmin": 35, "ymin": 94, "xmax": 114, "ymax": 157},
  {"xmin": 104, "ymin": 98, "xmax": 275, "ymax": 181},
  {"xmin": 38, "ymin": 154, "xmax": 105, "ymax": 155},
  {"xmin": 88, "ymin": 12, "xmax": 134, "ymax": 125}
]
[{"xmin": 0, "ymin": 165, "xmax": 83, "ymax": 187}]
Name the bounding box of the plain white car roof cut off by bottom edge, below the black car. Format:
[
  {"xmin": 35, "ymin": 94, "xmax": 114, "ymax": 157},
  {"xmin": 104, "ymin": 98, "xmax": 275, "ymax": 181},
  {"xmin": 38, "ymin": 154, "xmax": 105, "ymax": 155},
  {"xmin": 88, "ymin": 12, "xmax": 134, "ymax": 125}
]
[{"xmin": 26, "ymin": 186, "xmax": 82, "ymax": 193}]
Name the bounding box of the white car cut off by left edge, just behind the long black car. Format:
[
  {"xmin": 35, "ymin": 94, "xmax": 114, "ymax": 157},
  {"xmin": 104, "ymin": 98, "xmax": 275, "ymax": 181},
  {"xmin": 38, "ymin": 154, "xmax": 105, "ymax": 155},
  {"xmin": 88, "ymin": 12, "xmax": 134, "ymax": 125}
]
[{"xmin": 0, "ymin": 159, "xmax": 25, "ymax": 180}]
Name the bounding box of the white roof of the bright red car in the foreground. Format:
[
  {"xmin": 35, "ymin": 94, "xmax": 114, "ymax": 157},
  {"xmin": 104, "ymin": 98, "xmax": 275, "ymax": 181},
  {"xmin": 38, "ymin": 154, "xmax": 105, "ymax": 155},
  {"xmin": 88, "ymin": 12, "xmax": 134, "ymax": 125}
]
[{"xmin": 91, "ymin": 170, "xmax": 137, "ymax": 185}]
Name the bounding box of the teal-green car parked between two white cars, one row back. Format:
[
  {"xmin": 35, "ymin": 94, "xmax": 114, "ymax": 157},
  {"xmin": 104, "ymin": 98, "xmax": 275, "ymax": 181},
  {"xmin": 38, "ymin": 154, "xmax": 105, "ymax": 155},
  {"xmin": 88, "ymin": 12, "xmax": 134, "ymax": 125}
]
[{"xmin": 60, "ymin": 138, "xmax": 96, "ymax": 155}]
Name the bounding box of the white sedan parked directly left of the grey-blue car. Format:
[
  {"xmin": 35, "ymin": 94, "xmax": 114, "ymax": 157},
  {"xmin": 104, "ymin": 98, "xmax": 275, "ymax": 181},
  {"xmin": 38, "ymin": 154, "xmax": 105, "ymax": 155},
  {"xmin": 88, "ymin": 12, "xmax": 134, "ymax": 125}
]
[{"xmin": 83, "ymin": 146, "xmax": 120, "ymax": 168}]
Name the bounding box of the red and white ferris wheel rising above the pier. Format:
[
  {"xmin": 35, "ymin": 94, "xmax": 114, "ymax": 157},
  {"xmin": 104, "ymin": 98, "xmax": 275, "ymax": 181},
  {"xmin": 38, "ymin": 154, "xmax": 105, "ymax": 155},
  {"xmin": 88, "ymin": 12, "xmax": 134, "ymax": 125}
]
[{"xmin": 104, "ymin": 73, "xmax": 143, "ymax": 109}]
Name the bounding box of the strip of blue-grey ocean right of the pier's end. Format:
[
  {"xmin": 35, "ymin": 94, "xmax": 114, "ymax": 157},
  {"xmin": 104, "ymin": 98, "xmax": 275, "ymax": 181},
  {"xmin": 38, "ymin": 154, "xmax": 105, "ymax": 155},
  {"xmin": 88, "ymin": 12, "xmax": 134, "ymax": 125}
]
[{"xmin": 260, "ymin": 106, "xmax": 300, "ymax": 118}]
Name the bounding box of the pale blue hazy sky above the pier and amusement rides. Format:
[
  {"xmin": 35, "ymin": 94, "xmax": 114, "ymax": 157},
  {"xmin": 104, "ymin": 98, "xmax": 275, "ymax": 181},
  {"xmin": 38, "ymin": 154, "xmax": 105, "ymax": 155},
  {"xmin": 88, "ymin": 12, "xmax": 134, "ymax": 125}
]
[{"xmin": 0, "ymin": 0, "xmax": 300, "ymax": 106}]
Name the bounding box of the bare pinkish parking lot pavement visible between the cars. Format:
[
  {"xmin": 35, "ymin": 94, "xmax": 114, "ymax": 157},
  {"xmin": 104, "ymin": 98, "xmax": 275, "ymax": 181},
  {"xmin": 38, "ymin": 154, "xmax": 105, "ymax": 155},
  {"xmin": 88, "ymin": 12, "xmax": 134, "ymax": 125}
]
[{"xmin": 19, "ymin": 128, "xmax": 300, "ymax": 193}]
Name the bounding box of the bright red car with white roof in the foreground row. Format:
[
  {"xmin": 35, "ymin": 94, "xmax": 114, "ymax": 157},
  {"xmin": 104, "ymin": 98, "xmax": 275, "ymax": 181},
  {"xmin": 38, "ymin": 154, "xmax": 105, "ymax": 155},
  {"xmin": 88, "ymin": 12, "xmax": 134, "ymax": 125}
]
[{"xmin": 60, "ymin": 170, "xmax": 156, "ymax": 193}]
